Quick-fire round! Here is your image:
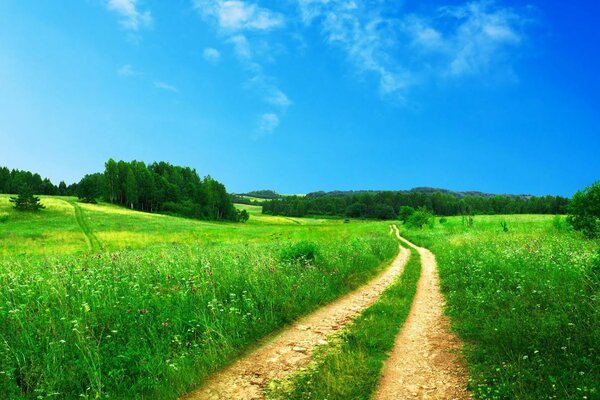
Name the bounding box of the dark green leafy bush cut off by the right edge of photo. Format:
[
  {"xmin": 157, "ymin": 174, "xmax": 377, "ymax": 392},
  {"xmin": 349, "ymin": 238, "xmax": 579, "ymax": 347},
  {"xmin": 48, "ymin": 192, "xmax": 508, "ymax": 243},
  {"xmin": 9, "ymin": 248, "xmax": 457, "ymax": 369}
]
[{"xmin": 567, "ymin": 182, "xmax": 600, "ymax": 238}]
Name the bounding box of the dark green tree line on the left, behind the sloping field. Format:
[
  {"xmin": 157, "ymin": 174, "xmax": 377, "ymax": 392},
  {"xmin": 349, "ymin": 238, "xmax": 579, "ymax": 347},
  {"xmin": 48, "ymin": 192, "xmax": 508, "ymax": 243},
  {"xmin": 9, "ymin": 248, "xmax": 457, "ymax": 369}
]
[{"xmin": 0, "ymin": 159, "xmax": 249, "ymax": 221}]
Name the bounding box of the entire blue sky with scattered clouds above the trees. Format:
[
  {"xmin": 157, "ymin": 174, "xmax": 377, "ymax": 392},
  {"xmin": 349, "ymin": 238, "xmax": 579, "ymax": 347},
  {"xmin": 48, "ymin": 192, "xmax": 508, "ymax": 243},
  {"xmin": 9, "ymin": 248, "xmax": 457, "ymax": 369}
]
[{"xmin": 0, "ymin": 0, "xmax": 600, "ymax": 195}]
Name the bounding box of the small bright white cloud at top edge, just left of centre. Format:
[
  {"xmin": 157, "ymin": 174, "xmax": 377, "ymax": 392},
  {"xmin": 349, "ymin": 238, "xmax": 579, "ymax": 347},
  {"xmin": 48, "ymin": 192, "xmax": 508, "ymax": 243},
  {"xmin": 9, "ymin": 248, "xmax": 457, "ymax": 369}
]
[{"xmin": 194, "ymin": 0, "xmax": 285, "ymax": 32}]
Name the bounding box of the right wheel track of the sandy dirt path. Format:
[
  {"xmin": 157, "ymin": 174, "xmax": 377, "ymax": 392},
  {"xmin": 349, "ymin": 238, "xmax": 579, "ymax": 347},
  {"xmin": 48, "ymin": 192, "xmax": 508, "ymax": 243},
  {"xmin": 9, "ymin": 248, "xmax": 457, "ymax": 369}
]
[{"xmin": 375, "ymin": 238, "xmax": 471, "ymax": 400}]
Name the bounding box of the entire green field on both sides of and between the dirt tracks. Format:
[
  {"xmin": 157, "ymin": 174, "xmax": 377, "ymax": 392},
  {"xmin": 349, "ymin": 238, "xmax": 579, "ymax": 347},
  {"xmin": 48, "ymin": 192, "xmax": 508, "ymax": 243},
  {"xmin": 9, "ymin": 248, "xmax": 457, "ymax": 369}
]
[{"xmin": 0, "ymin": 195, "xmax": 600, "ymax": 399}]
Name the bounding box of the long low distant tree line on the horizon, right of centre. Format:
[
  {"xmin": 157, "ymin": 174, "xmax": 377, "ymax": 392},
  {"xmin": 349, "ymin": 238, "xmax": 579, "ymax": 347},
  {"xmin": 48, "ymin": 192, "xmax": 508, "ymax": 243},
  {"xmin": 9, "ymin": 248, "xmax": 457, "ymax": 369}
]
[{"xmin": 262, "ymin": 191, "xmax": 569, "ymax": 219}]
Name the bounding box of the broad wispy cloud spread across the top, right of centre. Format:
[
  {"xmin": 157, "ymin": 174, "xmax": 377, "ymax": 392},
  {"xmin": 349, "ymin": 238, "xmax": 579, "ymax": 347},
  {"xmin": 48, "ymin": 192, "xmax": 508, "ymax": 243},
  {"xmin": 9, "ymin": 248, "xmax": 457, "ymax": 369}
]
[{"xmin": 296, "ymin": 0, "xmax": 524, "ymax": 97}]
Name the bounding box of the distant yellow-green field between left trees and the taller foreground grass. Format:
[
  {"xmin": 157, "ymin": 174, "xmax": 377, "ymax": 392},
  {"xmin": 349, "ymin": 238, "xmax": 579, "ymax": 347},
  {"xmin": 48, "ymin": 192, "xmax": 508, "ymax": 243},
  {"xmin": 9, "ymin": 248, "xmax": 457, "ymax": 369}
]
[{"xmin": 0, "ymin": 195, "xmax": 354, "ymax": 256}]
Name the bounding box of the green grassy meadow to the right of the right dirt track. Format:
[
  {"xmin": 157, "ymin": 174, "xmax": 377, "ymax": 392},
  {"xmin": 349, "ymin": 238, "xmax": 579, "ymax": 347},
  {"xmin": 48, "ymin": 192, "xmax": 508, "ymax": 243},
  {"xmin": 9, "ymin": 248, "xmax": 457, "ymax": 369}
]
[{"xmin": 402, "ymin": 216, "xmax": 600, "ymax": 400}]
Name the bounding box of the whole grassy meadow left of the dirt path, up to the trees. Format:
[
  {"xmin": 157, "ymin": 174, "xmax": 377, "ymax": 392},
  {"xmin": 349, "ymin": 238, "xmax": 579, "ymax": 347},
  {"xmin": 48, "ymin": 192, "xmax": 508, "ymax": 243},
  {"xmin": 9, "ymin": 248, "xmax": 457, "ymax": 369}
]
[{"xmin": 0, "ymin": 196, "xmax": 398, "ymax": 399}]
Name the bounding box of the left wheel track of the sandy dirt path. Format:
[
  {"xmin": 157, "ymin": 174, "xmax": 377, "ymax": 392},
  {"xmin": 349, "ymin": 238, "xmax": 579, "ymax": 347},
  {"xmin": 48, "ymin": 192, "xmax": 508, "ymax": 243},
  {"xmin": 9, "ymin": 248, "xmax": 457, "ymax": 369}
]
[{"xmin": 183, "ymin": 227, "xmax": 410, "ymax": 400}]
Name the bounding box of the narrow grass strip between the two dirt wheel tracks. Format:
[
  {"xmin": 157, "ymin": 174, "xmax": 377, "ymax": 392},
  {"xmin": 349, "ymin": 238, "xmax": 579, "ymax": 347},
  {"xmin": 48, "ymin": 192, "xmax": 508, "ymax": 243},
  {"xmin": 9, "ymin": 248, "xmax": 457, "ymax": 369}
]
[{"xmin": 267, "ymin": 244, "xmax": 421, "ymax": 400}]
